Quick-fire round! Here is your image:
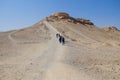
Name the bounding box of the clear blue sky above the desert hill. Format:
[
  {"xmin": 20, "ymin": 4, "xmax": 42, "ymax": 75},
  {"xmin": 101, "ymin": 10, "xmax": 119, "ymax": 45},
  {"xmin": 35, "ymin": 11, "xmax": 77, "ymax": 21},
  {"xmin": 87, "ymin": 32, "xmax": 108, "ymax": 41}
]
[{"xmin": 0, "ymin": 0, "xmax": 120, "ymax": 32}]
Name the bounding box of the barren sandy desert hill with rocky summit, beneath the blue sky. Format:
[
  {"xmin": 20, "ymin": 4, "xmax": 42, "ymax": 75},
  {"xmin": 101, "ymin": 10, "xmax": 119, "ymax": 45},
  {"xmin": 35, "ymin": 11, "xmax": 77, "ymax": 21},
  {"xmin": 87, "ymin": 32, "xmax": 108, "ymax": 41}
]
[{"xmin": 0, "ymin": 12, "xmax": 120, "ymax": 80}]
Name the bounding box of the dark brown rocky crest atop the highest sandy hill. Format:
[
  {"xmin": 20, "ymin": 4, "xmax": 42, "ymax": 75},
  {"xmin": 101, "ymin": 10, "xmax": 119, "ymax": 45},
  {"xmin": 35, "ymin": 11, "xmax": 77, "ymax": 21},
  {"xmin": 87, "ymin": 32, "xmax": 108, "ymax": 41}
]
[{"xmin": 46, "ymin": 12, "xmax": 94, "ymax": 25}]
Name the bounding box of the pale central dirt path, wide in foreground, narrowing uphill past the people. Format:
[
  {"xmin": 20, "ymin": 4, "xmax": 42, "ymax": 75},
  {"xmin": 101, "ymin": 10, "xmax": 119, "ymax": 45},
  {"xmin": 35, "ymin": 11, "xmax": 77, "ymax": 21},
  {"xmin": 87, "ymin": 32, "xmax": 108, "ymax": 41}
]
[{"xmin": 44, "ymin": 22, "xmax": 92, "ymax": 80}]
